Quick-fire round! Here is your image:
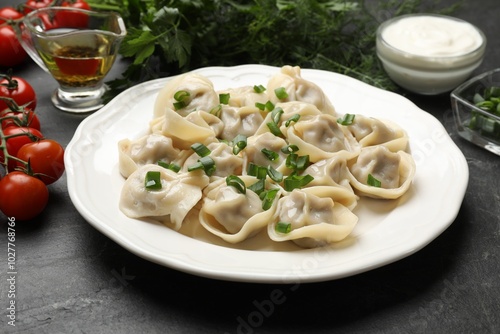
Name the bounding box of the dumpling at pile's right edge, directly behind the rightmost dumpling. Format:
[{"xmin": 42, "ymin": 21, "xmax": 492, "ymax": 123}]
[{"xmin": 346, "ymin": 115, "xmax": 408, "ymax": 152}]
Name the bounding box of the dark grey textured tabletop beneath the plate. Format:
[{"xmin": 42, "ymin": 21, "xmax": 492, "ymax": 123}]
[{"xmin": 0, "ymin": 0, "xmax": 500, "ymax": 333}]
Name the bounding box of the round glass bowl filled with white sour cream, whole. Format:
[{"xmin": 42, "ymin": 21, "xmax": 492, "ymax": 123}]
[{"xmin": 376, "ymin": 14, "xmax": 486, "ymax": 95}]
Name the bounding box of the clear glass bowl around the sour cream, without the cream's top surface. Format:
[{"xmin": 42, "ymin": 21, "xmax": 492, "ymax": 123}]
[{"xmin": 376, "ymin": 13, "xmax": 486, "ymax": 95}]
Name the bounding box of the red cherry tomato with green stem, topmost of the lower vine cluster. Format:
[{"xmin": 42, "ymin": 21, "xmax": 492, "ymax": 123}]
[{"xmin": 0, "ymin": 75, "xmax": 36, "ymax": 111}]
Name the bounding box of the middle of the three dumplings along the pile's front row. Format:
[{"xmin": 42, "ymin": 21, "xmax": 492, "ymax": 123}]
[{"xmin": 199, "ymin": 176, "xmax": 277, "ymax": 243}]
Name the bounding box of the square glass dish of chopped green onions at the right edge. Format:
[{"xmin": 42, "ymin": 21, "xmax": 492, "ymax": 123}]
[{"xmin": 451, "ymin": 68, "xmax": 500, "ymax": 155}]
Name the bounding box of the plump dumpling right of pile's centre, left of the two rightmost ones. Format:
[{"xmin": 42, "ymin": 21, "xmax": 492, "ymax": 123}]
[{"xmin": 285, "ymin": 114, "xmax": 360, "ymax": 162}]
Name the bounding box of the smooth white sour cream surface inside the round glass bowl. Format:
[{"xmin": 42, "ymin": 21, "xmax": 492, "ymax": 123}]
[{"xmin": 382, "ymin": 15, "xmax": 483, "ymax": 57}]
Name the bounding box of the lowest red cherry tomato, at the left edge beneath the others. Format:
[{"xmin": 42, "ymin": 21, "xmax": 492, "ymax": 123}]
[{"xmin": 0, "ymin": 171, "xmax": 49, "ymax": 221}]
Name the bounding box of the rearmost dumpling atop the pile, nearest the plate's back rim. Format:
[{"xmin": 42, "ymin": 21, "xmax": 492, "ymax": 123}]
[{"xmin": 267, "ymin": 65, "xmax": 335, "ymax": 115}]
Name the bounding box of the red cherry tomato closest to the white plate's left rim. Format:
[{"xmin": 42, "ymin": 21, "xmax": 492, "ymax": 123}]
[{"xmin": 17, "ymin": 139, "xmax": 64, "ymax": 185}]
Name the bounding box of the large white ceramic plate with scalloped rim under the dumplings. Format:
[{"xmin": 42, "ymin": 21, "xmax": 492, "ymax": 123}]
[{"xmin": 65, "ymin": 65, "xmax": 469, "ymax": 283}]
